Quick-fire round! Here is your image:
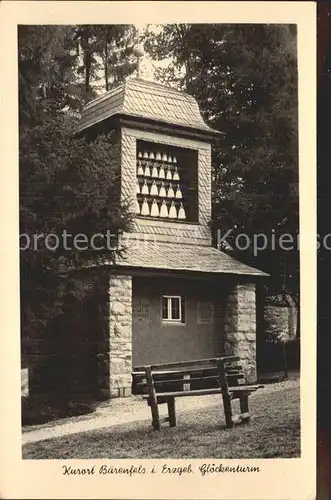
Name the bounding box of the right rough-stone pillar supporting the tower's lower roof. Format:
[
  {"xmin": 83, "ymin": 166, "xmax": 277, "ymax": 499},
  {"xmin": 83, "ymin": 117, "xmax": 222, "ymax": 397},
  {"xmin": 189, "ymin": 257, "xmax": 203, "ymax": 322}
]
[{"xmin": 224, "ymin": 283, "xmax": 257, "ymax": 383}]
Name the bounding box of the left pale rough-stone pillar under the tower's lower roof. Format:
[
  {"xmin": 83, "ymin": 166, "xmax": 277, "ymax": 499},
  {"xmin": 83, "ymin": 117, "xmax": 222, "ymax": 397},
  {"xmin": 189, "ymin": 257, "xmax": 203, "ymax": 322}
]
[{"xmin": 109, "ymin": 275, "xmax": 132, "ymax": 397}]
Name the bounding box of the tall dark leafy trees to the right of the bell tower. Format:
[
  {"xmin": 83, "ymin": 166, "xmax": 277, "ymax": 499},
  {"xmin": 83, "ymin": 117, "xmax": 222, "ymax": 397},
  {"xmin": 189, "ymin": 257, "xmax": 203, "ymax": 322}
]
[{"xmin": 144, "ymin": 24, "xmax": 299, "ymax": 298}]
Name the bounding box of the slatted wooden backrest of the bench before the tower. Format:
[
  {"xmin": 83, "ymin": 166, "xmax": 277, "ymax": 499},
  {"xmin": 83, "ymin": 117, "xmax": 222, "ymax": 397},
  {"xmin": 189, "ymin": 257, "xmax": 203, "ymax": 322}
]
[{"xmin": 132, "ymin": 356, "xmax": 245, "ymax": 395}]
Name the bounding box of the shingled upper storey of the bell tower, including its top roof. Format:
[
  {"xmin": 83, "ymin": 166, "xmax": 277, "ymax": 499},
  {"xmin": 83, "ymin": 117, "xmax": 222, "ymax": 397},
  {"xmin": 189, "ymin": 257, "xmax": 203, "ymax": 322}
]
[{"xmin": 77, "ymin": 78, "xmax": 221, "ymax": 245}]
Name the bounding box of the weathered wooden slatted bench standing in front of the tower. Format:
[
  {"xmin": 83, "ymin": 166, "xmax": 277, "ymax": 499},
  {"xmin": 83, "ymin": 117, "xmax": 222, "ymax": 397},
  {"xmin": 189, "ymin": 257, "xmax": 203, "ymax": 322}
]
[{"xmin": 132, "ymin": 356, "xmax": 263, "ymax": 430}]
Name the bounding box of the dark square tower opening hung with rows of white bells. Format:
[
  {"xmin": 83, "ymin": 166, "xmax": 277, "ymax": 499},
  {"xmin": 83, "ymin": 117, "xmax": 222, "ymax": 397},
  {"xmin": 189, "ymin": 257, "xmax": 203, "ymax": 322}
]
[{"xmin": 136, "ymin": 140, "xmax": 198, "ymax": 222}]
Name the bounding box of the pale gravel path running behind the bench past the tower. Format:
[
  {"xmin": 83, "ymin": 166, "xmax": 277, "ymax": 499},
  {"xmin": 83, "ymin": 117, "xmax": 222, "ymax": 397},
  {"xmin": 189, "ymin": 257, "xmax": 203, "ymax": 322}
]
[{"xmin": 22, "ymin": 379, "xmax": 299, "ymax": 444}]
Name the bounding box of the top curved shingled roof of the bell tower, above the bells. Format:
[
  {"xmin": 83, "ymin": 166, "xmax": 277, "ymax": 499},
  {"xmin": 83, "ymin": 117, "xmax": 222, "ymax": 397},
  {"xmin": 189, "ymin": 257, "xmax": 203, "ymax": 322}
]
[{"xmin": 77, "ymin": 78, "xmax": 220, "ymax": 135}]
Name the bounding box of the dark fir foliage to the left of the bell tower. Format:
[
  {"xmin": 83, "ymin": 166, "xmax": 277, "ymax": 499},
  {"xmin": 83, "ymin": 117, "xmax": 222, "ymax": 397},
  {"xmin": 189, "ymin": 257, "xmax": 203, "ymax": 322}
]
[{"xmin": 18, "ymin": 26, "xmax": 130, "ymax": 337}]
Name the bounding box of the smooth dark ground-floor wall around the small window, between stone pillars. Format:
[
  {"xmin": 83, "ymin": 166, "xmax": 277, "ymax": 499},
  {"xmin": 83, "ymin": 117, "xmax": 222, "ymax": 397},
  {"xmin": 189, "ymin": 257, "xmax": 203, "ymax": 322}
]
[{"xmin": 132, "ymin": 276, "xmax": 223, "ymax": 366}]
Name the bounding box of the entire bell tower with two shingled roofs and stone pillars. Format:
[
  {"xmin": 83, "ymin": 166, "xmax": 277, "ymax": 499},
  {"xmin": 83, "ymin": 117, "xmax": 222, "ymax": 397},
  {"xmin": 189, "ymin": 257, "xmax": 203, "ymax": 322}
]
[{"xmin": 78, "ymin": 54, "xmax": 265, "ymax": 397}]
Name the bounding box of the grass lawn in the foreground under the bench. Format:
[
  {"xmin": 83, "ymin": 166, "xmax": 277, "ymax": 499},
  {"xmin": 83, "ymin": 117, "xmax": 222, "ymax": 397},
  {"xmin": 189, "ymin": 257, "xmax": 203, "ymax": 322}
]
[{"xmin": 23, "ymin": 387, "xmax": 300, "ymax": 459}]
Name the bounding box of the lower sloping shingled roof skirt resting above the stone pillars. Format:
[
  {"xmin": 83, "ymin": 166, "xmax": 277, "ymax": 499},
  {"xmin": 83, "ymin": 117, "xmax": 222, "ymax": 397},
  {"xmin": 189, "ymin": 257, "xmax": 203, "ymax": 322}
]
[{"xmin": 105, "ymin": 240, "xmax": 268, "ymax": 276}]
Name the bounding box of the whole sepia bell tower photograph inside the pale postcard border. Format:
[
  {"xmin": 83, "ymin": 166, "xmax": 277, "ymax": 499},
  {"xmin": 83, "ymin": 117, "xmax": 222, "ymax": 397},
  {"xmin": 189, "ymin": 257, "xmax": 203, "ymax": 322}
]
[{"xmin": 18, "ymin": 24, "xmax": 300, "ymax": 459}]
